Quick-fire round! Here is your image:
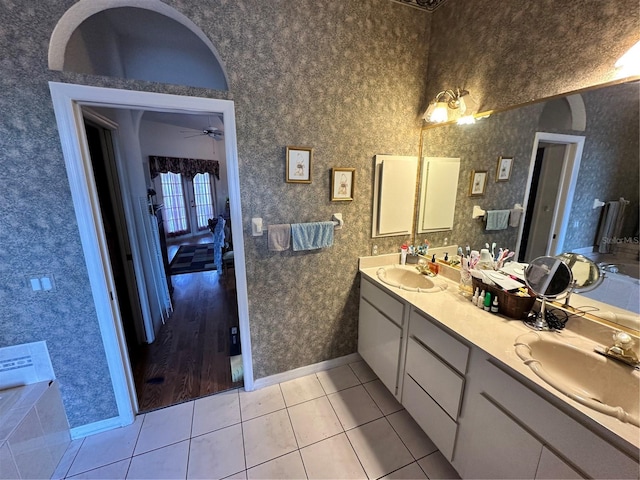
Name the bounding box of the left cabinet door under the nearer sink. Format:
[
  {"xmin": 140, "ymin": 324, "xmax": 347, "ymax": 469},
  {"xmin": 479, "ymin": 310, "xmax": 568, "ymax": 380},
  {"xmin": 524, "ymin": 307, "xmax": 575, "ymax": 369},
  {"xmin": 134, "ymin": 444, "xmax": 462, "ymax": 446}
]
[{"xmin": 455, "ymin": 395, "xmax": 542, "ymax": 479}]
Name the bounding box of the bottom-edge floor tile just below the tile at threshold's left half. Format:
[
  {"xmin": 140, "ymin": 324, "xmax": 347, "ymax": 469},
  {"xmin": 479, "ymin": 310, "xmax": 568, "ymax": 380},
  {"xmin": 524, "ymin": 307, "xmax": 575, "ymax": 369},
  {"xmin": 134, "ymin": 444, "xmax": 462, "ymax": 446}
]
[{"xmin": 127, "ymin": 440, "xmax": 189, "ymax": 480}]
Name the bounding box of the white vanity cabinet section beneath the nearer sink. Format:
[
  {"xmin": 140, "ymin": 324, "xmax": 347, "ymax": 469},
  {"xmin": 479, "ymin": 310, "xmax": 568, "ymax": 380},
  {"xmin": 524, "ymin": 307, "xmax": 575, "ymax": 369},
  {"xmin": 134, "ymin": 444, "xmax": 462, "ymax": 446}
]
[{"xmin": 453, "ymin": 349, "xmax": 640, "ymax": 479}]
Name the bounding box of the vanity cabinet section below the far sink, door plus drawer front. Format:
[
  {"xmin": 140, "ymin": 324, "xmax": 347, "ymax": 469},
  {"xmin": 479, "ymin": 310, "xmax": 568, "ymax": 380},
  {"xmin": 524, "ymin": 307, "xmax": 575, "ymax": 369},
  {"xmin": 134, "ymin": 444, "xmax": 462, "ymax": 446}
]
[{"xmin": 358, "ymin": 278, "xmax": 406, "ymax": 398}]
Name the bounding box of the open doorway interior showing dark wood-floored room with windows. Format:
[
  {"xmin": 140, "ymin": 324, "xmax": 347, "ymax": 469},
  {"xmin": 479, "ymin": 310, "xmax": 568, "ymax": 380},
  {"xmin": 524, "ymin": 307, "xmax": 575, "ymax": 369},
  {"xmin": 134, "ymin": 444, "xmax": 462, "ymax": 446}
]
[{"xmin": 82, "ymin": 107, "xmax": 242, "ymax": 412}]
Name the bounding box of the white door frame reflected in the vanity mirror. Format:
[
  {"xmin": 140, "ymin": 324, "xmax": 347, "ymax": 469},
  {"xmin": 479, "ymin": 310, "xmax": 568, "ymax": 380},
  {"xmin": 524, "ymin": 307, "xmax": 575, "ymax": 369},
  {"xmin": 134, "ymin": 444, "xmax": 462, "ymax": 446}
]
[{"xmin": 516, "ymin": 132, "xmax": 585, "ymax": 258}]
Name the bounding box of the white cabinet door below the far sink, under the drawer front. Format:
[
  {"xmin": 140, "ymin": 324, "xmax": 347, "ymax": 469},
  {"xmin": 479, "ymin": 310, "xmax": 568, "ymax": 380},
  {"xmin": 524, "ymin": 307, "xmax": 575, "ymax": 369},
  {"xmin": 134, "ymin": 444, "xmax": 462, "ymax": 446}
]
[{"xmin": 358, "ymin": 299, "xmax": 402, "ymax": 395}]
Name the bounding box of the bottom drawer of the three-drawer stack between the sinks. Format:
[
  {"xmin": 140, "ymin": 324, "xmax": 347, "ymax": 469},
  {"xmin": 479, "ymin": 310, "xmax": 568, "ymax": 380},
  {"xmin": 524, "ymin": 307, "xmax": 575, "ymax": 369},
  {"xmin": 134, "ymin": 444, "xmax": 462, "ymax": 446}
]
[{"xmin": 402, "ymin": 374, "xmax": 457, "ymax": 461}]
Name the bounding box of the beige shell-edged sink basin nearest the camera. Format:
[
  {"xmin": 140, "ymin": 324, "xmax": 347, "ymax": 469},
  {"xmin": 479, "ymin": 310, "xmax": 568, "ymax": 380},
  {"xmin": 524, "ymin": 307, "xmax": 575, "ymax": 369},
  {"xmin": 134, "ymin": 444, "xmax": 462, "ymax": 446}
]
[{"xmin": 515, "ymin": 332, "xmax": 640, "ymax": 427}]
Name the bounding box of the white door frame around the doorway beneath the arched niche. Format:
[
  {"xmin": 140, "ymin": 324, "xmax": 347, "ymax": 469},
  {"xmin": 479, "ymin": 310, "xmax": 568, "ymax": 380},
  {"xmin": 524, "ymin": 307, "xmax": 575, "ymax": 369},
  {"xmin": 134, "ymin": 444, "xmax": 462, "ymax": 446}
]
[{"xmin": 50, "ymin": 82, "xmax": 253, "ymax": 436}]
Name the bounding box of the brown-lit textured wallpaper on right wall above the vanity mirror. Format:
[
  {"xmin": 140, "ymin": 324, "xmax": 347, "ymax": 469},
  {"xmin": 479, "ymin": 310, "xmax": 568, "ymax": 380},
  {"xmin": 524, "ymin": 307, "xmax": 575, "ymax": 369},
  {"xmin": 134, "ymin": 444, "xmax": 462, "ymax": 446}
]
[{"xmin": 424, "ymin": 0, "xmax": 640, "ymax": 111}]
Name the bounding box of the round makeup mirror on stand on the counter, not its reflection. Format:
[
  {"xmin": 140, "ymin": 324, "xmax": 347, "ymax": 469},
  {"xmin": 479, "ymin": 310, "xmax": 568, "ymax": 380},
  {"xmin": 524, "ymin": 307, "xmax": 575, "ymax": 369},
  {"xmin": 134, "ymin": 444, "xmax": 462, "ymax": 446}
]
[{"xmin": 524, "ymin": 257, "xmax": 573, "ymax": 330}]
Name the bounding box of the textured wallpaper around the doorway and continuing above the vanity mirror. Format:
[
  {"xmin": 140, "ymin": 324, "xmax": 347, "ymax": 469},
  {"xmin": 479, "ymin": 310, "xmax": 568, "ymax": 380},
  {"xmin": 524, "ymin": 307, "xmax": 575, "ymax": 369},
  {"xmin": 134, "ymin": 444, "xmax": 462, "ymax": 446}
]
[{"xmin": 0, "ymin": 0, "xmax": 635, "ymax": 426}]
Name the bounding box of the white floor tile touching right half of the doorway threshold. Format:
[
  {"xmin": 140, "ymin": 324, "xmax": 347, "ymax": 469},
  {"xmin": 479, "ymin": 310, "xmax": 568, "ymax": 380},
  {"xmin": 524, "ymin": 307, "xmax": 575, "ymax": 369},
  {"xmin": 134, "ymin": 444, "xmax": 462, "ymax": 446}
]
[{"xmin": 191, "ymin": 390, "xmax": 240, "ymax": 437}]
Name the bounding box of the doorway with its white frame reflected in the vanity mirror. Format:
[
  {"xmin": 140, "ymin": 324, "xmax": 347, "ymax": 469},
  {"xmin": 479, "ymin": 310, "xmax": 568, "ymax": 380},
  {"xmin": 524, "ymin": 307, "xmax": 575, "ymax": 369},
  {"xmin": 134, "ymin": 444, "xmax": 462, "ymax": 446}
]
[{"xmin": 516, "ymin": 132, "xmax": 585, "ymax": 263}]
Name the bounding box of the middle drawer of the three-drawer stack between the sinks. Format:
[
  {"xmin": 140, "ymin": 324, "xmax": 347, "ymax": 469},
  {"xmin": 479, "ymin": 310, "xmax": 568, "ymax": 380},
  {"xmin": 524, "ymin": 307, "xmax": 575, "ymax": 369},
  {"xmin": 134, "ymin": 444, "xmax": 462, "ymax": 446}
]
[{"xmin": 406, "ymin": 338, "xmax": 464, "ymax": 420}]
